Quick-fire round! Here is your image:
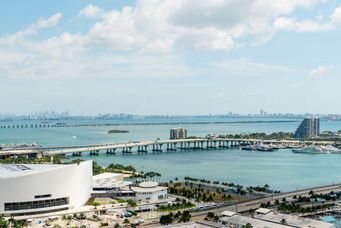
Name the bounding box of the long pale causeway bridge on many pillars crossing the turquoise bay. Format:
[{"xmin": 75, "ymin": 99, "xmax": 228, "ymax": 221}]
[{"xmin": 0, "ymin": 138, "xmax": 333, "ymax": 158}]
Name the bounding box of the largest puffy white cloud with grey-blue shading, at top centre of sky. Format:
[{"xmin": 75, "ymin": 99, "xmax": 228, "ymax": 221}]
[{"xmin": 77, "ymin": 0, "xmax": 332, "ymax": 53}]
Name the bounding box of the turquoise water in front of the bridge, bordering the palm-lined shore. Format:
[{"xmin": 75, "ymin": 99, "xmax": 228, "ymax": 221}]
[{"xmin": 77, "ymin": 149, "xmax": 341, "ymax": 191}]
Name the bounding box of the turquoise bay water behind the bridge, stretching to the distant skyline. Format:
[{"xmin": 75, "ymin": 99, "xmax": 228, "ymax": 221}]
[{"xmin": 0, "ymin": 119, "xmax": 341, "ymax": 146}]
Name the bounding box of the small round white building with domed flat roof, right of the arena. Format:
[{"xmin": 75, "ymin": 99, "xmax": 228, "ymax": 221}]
[{"xmin": 131, "ymin": 181, "xmax": 168, "ymax": 202}]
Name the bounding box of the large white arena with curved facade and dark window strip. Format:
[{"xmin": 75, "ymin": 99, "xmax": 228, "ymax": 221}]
[{"xmin": 0, "ymin": 160, "xmax": 92, "ymax": 216}]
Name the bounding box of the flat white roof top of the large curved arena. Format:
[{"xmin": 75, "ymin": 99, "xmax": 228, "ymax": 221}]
[{"xmin": 0, "ymin": 164, "xmax": 66, "ymax": 178}]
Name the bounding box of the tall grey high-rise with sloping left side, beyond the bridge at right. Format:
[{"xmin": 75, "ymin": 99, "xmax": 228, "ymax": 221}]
[{"xmin": 294, "ymin": 117, "xmax": 320, "ymax": 139}]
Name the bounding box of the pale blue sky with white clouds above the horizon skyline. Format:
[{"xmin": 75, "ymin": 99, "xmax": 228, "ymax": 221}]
[{"xmin": 0, "ymin": 0, "xmax": 341, "ymax": 115}]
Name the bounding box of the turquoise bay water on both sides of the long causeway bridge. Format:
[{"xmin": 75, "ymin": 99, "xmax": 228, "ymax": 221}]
[{"xmin": 0, "ymin": 118, "xmax": 341, "ymax": 191}]
